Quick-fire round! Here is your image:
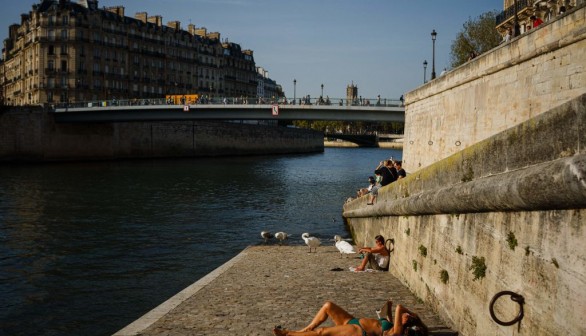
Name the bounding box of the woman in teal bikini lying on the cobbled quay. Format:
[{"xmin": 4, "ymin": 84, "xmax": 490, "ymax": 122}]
[{"xmin": 273, "ymin": 300, "xmax": 428, "ymax": 336}]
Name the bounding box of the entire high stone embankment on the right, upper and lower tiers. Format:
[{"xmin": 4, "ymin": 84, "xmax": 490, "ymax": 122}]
[{"xmin": 344, "ymin": 5, "xmax": 586, "ymax": 336}]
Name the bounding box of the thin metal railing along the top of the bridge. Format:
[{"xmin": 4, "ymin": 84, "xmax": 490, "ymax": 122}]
[{"xmin": 53, "ymin": 96, "xmax": 403, "ymax": 109}]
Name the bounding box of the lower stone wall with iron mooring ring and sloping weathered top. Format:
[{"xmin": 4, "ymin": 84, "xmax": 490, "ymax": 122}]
[{"xmin": 344, "ymin": 94, "xmax": 586, "ymax": 336}]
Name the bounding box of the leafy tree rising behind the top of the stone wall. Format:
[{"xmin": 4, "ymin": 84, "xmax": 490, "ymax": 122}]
[{"xmin": 451, "ymin": 11, "xmax": 502, "ymax": 68}]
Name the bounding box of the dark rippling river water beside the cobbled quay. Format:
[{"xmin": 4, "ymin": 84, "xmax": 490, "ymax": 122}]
[{"xmin": 0, "ymin": 148, "xmax": 402, "ymax": 335}]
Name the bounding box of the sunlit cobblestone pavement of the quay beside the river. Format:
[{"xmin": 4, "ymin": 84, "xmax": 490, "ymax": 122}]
[{"xmin": 120, "ymin": 246, "xmax": 452, "ymax": 335}]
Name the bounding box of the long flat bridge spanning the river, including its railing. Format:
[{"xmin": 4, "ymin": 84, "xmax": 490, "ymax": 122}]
[{"xmin": 54, "ymin": 101, "xmax": 405, "ymax": 123}]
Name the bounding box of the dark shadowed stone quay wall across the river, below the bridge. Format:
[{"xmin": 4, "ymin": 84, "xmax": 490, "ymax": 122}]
[{"xmin": 0, "ymin": 107, "xmax": 324, "ymax": 162}]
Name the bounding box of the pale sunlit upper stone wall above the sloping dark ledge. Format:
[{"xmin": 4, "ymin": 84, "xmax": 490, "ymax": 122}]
[{"xmin": 403, "ymin": 4, "xmax": 586, "ymax": 172}]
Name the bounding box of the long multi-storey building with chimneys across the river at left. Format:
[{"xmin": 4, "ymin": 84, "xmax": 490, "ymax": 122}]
[{"xmin": 0, "ymin": 0, "xmax": 278, "ymax": 105}]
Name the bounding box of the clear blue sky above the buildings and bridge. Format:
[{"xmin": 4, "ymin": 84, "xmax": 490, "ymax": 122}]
[{"xmin": 0, "ymin": 0, "xmax": 503, "ymax": 99}]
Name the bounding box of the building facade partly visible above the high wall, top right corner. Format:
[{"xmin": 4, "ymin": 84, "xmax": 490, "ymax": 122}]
[{"xmin": 496, "ymin": 0, "xmax": 584, "ymax": 35}]
